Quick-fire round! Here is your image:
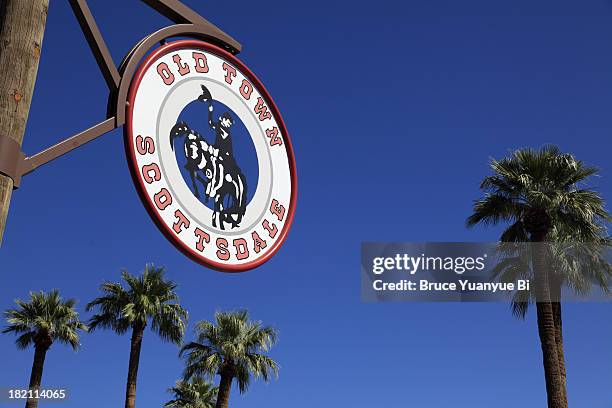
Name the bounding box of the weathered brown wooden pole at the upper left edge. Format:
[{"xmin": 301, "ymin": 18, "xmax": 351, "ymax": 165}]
[{"xmin": 0, "ymin": 0, "xmax": 49, "ymax": 244}]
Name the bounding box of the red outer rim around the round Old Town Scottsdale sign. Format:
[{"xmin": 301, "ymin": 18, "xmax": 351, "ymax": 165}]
[{"xmin": 123, "ymin": 40, "xmax": 297, "ymax": 273}]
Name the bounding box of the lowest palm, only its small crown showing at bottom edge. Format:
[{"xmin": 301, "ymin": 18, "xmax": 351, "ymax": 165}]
[{"xmin": 164, "ymin": 377, "xmax": 219, "ymax": 408}]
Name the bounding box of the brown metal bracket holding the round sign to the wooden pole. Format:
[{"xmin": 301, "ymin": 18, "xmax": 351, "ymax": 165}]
[{"xmin": 0, "ymin": 0, "xmax": 242, "ymax": 188}]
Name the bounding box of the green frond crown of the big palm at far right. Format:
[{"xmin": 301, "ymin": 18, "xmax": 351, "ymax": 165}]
[{"xmin": 467, "ymin": 146, "xmax": 612, "ymax": 317}]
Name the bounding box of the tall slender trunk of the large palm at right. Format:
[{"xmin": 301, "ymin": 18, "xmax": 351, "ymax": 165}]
[{"xmin": 533, "ymin": 243, "xmax": 567, "ymax": 408}]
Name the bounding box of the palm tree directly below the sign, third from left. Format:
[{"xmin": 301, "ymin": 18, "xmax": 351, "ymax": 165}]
[{"xmin": 180, "ymin": 310, "xmax": 278, "ymax": 408}]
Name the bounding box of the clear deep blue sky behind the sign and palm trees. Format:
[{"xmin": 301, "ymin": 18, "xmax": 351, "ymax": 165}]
[{"xmin": 0, "ymin": 0, "xmax": 612, "ymax": 408}]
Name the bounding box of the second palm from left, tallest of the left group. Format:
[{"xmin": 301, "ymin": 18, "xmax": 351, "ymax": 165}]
[{"xmin": 87, "ymin": 264, "xmax": 187, "ymax": 408}]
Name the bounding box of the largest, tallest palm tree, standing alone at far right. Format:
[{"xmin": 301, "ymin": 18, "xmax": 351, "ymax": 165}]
[{"xmin": 467, "ymin": 146, "xmax": 611, "ymax": 408}]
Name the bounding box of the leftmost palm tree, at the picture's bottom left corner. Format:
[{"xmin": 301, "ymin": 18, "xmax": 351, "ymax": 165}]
[{"xmin": 2, "ymin": 290, "xmax": 87, "ymax": 408}]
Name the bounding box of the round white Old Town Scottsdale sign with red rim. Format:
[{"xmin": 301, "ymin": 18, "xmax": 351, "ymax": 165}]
[{"xmin": 125, "ymin": 40, "xmax": 297, "ymax": 272}]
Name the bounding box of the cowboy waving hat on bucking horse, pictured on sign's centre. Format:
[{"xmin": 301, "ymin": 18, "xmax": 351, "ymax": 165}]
[{"xmin": 170, "ymin": 85, "xmax": 247, "ymax": 230}]
